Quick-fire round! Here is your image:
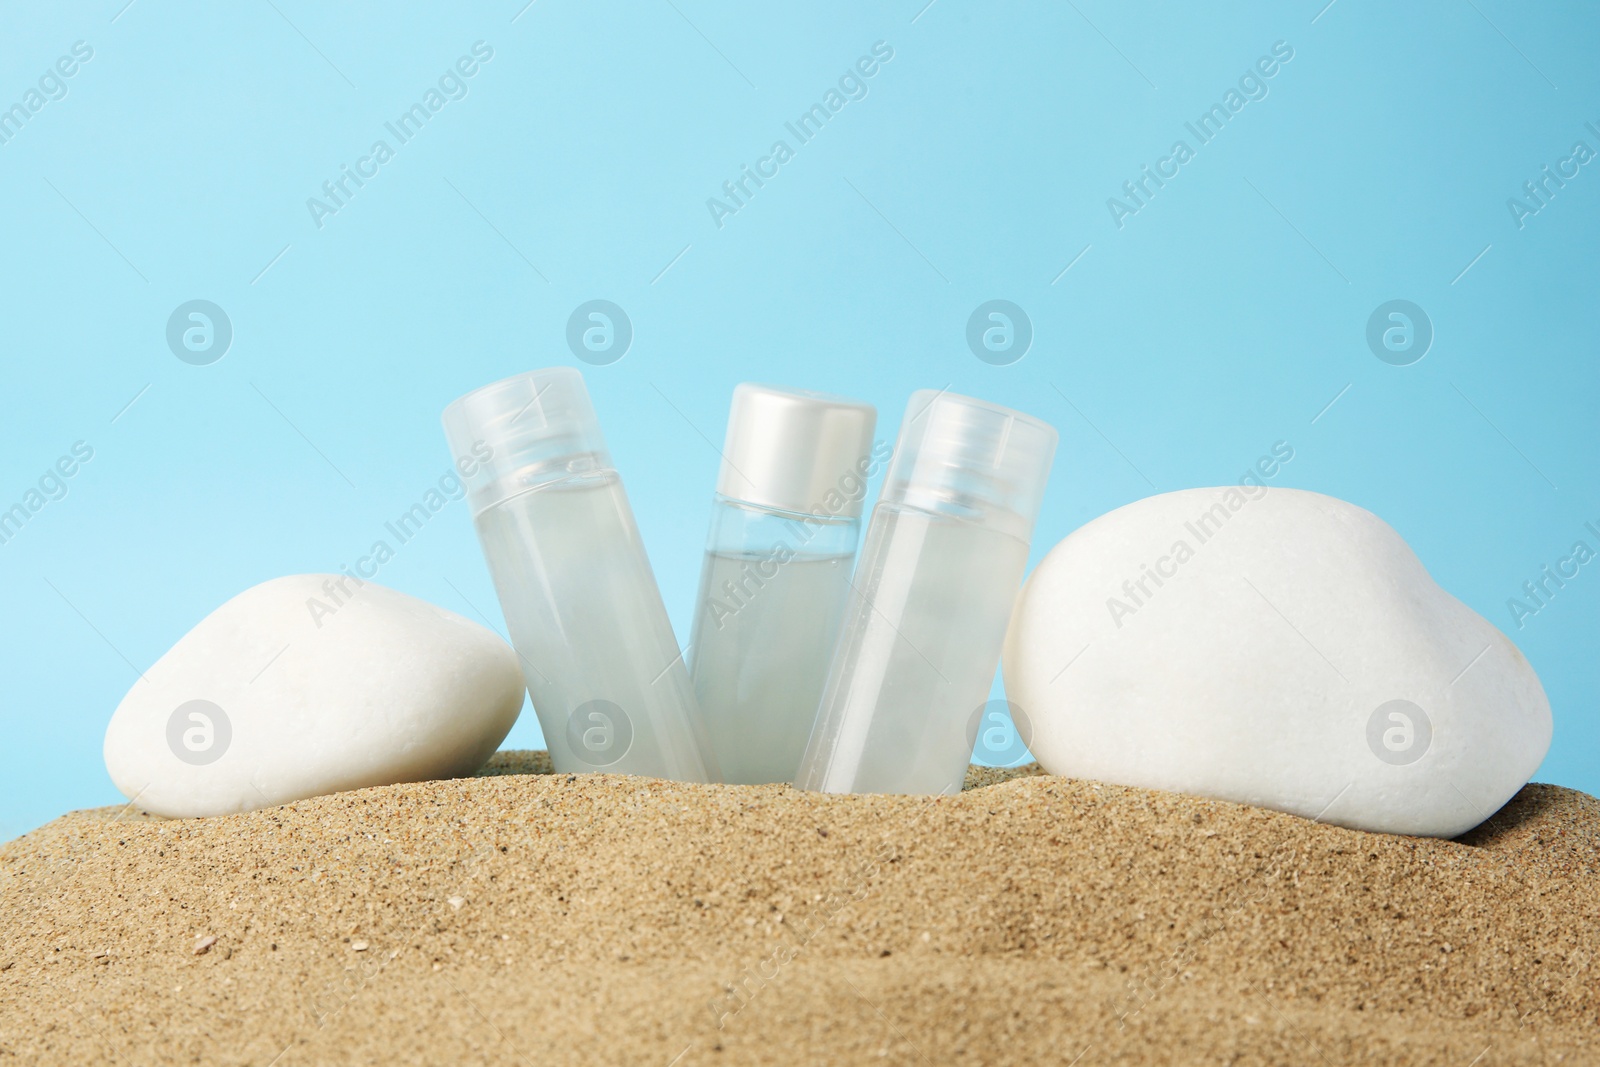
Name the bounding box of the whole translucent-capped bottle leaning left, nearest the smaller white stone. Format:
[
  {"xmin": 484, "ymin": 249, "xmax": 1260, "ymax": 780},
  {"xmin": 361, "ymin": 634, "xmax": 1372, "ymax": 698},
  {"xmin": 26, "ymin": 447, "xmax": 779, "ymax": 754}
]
[{"xmin": 445, "ymin": 366, "xmax": 717, "ymax": 782}]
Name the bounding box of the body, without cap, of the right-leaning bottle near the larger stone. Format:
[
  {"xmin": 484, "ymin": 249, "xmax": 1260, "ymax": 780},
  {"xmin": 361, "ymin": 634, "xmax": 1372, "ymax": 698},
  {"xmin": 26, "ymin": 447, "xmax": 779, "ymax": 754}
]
[{"xmin": 795, "ymin": 502, "xmax": 1029, "ymax": 793}]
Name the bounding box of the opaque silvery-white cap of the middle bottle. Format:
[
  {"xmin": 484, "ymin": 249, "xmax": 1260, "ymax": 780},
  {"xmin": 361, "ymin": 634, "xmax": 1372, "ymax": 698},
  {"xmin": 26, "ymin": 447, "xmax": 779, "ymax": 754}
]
[{"xmin": 717, "ymin": 382, "xmax": 878, "ymax": 517}]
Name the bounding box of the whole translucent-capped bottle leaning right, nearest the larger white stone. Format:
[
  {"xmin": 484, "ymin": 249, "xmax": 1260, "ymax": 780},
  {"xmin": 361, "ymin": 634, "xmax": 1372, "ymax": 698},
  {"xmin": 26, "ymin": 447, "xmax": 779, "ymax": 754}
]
[{"xmin": 795, "ymin": 390, "xmax": 1056, "ymax": 793}]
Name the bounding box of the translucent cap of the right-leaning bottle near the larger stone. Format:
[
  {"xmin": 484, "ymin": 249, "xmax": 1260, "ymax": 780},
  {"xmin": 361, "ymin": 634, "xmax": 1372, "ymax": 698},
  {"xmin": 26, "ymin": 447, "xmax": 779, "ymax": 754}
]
[{"xmin": 882, "ymin": 389, "xmax": 1058, "ymax": 537}]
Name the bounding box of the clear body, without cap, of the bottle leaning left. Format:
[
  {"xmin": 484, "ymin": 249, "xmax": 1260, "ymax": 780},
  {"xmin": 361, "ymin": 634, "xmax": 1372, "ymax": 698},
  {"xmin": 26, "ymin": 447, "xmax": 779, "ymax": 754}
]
[{"xmin": 474, "ymin": 469, "xmax": 715, "ymax": 782}]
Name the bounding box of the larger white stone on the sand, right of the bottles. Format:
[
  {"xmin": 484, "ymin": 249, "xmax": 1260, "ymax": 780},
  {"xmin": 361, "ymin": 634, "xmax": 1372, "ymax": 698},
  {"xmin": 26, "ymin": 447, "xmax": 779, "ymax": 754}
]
[{"xmin": 1005, "ymin": 485, "xmax": 1550, "ymax": 837}]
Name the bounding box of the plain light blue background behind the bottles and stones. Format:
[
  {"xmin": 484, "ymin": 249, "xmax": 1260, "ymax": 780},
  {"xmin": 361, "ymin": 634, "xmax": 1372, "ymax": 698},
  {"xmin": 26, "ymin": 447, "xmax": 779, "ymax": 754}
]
[{"xmin": 0, "ymin": 0, "xmax": 1600, "ymax": 838}]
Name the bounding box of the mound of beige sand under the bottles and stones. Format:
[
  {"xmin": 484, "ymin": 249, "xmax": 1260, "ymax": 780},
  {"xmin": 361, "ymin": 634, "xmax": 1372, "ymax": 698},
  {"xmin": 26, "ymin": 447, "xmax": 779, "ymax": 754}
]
[{"xmin": 0, "ymin": 753, "xmax": 1600, "ymax": 1067}]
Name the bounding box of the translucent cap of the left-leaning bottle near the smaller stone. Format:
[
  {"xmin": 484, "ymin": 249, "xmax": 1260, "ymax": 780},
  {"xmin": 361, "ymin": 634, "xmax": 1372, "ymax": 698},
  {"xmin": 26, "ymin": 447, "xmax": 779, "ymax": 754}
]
[{"xmin": 445, "ymin": 366, "xmax": 611, "ymax": 515}]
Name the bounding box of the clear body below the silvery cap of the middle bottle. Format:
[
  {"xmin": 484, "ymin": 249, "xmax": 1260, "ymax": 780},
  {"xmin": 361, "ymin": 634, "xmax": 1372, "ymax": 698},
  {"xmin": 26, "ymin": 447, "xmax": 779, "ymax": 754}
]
[{"xmin": 690, "ymin": 494, "xmax": 861, "ymax": 784}]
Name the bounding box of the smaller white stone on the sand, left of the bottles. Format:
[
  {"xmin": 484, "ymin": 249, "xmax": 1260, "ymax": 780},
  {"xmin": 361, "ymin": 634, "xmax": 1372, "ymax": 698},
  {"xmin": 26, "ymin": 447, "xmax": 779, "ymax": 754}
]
[{"xmin": 106, "ymin": 574, "xmax": 523, "ymax": 816}]
